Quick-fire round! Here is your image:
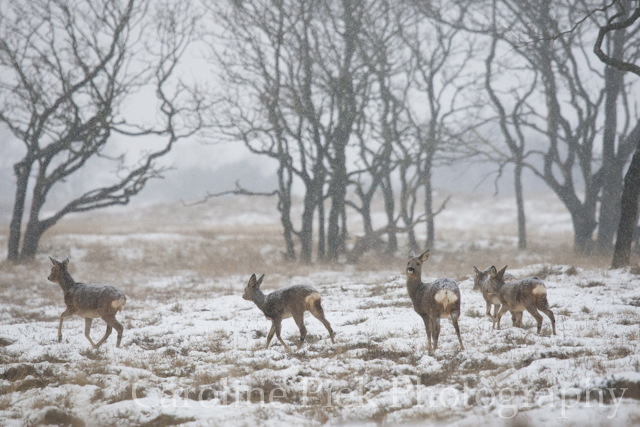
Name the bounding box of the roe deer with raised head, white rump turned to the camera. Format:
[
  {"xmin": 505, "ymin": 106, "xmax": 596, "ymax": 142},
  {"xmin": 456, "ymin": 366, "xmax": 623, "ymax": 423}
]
[{"xmin": 406, "ymin": 250, "xmax": 464, "ymax": 351}]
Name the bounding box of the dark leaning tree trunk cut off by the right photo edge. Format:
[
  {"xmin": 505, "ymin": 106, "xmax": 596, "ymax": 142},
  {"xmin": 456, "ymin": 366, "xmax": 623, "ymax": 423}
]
[{"xmin": 611, "ymin": 140, "xmax": 640, "ymax": 268}]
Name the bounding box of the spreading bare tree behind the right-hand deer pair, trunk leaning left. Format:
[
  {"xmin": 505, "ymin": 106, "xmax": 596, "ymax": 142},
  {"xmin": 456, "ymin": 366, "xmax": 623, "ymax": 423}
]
[{"xmin": 472, "ymin": 0, "xmax": 635, "ymax": 254}]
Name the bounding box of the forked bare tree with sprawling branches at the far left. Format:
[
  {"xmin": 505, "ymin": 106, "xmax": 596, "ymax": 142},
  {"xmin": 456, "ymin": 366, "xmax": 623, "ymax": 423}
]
[{"xmin": 0, "ymin": 0, "xmax": 206, "ymax": 261}]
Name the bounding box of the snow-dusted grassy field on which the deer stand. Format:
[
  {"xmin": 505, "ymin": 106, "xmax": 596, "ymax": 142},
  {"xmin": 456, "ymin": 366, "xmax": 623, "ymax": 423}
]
[{"xmin": 0, "ymin": 197, "xmax": 640, "ymax": 426}]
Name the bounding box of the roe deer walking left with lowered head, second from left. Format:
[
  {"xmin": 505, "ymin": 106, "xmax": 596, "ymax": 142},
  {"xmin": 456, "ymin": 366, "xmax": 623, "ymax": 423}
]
[{"xmin": 242, "ymin": 274, "xmax": 335, "ymax": 351}]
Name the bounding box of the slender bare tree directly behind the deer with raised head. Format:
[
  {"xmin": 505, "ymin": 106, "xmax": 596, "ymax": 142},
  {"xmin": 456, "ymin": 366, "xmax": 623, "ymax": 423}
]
[{"xmin": 401, "ymin": 1, "xmax": 477, "ymax": 248}]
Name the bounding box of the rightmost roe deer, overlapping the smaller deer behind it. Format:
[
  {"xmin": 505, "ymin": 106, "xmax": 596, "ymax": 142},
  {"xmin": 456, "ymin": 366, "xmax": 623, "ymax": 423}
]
[{"xmin": 488, "ymin": 266, "xmax": 556, "ymax": 335}]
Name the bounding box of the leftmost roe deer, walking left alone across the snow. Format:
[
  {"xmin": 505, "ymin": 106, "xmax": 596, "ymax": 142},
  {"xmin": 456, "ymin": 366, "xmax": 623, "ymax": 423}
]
[{"xmin": 48, "ymin": 257, "xmax": 127, "ymax": 348}]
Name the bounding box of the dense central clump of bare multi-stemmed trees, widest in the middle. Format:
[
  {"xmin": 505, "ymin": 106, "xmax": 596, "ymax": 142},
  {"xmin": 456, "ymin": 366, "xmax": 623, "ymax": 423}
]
[{"xmin": 211, "ymin": 0, "xmax": 368, "ymax": 263}]
